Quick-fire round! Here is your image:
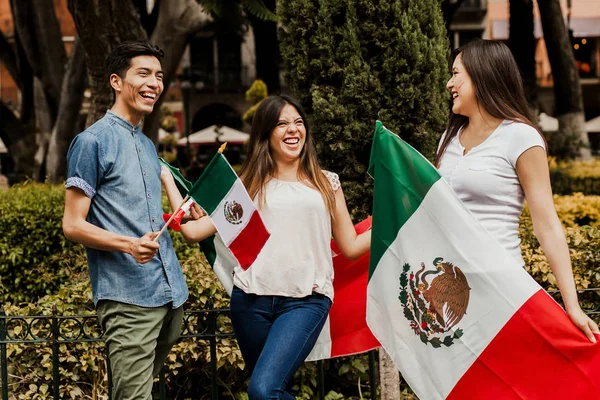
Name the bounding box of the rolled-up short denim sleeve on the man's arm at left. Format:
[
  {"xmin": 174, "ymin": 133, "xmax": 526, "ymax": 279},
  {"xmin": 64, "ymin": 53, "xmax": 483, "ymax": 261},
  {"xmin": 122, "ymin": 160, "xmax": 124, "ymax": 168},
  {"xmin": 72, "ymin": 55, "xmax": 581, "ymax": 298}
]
[{"xmin": 65, "ymin": 132, "xmax": 102, "ymax": 199}]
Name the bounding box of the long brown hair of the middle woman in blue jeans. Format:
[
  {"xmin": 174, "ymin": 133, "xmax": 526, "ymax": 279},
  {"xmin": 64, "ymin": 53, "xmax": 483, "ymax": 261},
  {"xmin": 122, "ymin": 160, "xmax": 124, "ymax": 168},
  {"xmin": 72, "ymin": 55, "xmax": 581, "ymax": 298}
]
[{"xmin": 240, "ymin": 95, "xmax": 335, "ymax": 218}]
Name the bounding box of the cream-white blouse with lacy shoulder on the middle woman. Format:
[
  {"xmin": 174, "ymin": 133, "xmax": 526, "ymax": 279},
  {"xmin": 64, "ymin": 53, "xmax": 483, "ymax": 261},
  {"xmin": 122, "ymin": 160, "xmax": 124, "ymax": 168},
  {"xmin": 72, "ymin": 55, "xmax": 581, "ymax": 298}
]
[{"xmin": 233, "ymin": 171, "xmax": 340, "ymax": 300}]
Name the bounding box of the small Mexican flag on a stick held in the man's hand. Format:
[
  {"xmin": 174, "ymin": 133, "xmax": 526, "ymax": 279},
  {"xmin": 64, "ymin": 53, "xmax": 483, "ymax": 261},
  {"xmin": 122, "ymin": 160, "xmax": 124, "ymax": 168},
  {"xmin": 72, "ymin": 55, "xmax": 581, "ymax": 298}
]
[{"xmin": 162, "ymin": 152, "xmax": 270, "ymax": 270}]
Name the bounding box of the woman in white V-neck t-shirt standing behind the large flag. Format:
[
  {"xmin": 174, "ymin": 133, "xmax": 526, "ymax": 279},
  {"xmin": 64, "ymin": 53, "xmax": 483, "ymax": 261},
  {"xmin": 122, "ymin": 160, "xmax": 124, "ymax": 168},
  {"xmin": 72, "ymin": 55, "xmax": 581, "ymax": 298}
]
[{"xmin": 435, "ymin": 40, "xmax": 600, "ymax": 343}]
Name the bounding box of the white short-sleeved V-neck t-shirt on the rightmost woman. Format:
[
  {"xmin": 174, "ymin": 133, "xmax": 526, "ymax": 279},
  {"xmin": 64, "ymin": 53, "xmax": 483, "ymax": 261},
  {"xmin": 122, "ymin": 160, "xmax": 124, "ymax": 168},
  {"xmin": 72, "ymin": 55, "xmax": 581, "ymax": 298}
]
[{"xmin": 439, "ymin": 120, "xmax": 546, "ymax": 265}]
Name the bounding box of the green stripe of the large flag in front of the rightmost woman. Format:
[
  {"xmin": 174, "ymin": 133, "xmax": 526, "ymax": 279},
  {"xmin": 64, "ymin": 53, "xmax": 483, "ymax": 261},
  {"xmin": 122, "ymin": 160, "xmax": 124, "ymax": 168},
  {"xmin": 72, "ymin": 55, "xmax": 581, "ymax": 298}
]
[{"xmin": 369, "ymin": 121, "xmax": 440, "ymax": 279}]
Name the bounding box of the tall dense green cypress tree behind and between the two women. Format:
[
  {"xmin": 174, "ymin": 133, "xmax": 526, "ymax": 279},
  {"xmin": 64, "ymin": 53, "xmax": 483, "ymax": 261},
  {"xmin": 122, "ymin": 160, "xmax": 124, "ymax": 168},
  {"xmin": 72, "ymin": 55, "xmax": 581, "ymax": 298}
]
[{"xmin": 278, "ymin": 0, "xmax": 449, "ymax": 218}]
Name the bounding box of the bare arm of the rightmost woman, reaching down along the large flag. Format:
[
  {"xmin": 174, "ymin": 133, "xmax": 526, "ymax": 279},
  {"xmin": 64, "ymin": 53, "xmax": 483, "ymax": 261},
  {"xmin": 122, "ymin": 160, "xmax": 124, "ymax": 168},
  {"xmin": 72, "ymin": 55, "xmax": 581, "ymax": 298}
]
[{"xmin": 517, "ymin": 147, "xmax": 600, "ymax": 343}]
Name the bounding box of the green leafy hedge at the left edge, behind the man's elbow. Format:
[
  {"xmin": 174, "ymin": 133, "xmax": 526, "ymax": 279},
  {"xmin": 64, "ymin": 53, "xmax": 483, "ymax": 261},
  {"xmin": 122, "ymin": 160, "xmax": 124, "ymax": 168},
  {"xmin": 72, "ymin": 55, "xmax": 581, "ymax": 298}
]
[{"xmin": 0, "ymin": 183, "xmax": 84, "ymax": 303}]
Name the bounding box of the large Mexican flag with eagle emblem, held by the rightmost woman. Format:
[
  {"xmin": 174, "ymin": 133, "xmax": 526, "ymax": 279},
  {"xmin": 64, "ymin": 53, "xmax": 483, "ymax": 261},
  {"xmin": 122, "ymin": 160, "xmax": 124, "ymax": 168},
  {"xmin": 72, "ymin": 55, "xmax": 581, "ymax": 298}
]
[{"xmin": 367, "ymin": 122, "xmax": 600, "ymax": 400}]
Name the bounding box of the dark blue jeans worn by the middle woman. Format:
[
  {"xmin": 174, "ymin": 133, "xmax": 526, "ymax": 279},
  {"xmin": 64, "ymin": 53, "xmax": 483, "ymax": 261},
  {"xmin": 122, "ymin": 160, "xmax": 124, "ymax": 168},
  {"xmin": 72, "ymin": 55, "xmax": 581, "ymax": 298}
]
[{"xmin": 231, "ymin": 286, "xmax": 331, "ymax": 400}]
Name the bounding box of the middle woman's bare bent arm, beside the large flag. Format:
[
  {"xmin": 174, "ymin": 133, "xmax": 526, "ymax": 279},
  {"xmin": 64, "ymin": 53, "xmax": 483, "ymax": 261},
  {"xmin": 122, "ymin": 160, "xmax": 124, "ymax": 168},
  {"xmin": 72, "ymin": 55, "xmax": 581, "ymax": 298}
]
[{"xmin": 331, "ymin": 187, "xmax": 371, "ymax": 260}]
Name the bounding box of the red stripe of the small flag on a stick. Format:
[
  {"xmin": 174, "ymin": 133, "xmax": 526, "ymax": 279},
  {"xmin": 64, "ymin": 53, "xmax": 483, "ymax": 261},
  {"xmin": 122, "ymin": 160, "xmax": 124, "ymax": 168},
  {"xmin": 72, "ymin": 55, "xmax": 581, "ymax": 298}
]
[{"xmin": 228, "ymin": 210, "xmax": 271, "ymax": 271}]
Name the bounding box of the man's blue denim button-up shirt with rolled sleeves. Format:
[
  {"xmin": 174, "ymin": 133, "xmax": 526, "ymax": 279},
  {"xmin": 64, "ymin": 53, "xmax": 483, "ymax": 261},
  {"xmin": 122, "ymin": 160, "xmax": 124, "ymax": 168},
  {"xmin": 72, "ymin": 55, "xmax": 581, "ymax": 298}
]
[{"xmin": 65, "ymin": 111, "xmax": 188, "ymax": 308}]
